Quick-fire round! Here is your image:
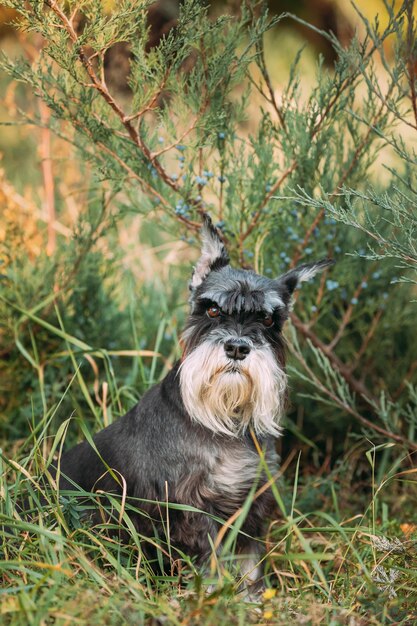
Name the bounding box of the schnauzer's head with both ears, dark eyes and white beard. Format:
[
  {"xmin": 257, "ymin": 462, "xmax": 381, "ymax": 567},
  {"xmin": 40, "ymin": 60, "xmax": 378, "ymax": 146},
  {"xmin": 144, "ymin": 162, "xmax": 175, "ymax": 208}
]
[{"xmin": 180, "ymin": 216, "xmax": 332, "ymax": 435}]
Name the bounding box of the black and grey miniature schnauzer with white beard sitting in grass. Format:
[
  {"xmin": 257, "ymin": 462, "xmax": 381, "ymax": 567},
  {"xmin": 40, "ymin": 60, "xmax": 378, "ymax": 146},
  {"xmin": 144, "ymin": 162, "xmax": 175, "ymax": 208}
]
[{"xmin": 59, "ymin": 216, "xmax": 332, "ymax": 581}]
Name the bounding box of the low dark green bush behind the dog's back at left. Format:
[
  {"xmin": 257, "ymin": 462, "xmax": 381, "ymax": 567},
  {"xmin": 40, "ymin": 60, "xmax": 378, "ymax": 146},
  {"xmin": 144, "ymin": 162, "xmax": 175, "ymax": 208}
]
[{"xmin": 0, "ymin": 219, "xmax": 184, "ymax": 440}]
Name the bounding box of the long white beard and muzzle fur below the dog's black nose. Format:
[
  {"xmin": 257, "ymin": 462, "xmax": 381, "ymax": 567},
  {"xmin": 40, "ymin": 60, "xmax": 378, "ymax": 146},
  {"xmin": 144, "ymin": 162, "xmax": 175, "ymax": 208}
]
[{"xmin": 180, "ymin": 341, "xmax": 287, "ymax": 436}]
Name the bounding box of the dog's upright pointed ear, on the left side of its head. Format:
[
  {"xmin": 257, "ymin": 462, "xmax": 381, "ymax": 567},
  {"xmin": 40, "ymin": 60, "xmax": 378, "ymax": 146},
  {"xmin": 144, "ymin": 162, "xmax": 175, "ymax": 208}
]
[{"xmin": 190, "ymin": 213, "xmax": 229, "ymax": 289}]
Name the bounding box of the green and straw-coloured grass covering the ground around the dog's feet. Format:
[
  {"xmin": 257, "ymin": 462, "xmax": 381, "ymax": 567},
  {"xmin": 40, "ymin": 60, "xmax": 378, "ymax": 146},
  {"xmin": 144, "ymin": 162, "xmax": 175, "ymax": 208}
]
[{"xmin": 0, "ymin": 458, "xmax": 417, "ymax": 625}]
